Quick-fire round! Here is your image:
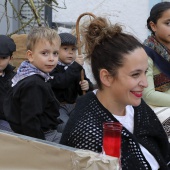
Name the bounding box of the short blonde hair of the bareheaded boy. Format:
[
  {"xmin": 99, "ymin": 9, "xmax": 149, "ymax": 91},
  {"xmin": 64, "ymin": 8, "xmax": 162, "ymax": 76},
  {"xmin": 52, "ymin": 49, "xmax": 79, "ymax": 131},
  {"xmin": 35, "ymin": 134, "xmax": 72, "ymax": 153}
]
[{"xmin": 27, "ymin": 27, "xmax": 61, "ymax": 51}]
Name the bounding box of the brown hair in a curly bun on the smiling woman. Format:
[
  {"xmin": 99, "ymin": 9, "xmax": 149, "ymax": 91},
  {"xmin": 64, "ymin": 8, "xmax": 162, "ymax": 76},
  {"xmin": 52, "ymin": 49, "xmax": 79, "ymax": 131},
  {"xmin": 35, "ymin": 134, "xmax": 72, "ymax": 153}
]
[{"xmin": 82, "ymin": 17, "xmax": 143, "ymax": 88}]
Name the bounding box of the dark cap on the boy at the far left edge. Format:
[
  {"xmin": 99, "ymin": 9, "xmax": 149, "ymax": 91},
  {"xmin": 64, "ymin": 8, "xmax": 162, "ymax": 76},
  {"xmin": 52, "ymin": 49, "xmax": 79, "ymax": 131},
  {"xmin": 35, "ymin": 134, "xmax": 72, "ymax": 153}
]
[{"xmin": 0, "ymin": 35, "xmax": 16, "ymax": 58}]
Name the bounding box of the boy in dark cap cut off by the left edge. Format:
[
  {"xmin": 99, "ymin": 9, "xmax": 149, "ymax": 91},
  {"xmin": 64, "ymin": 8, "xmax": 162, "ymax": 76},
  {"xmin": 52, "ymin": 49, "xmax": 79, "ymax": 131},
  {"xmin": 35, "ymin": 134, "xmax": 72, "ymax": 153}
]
[{"xmin": 0, "ymin": 35, "xmax": 16, "ymax": 131}]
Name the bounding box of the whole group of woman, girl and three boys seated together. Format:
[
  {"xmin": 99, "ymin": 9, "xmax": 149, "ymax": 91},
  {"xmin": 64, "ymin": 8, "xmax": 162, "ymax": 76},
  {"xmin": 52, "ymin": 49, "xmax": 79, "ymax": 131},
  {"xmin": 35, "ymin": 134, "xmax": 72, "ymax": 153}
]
[{"xmin": 0, "ymin": 2, "xmax": 170, "ymax": 170}]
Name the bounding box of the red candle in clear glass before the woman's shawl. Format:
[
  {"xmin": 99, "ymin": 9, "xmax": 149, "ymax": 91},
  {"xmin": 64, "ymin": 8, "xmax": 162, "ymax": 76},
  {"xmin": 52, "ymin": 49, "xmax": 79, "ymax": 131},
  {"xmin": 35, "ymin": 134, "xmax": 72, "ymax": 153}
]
[{"xmin": 103, "ymin": 122, "xmax": 122, "ymax": 158}]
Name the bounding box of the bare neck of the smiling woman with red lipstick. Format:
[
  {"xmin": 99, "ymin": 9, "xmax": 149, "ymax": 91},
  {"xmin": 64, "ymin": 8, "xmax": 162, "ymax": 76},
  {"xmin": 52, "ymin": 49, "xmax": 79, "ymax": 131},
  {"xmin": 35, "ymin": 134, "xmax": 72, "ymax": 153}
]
[{"xmin": 96, "ymin": 90, "xmax": 125, "ymax": 116}]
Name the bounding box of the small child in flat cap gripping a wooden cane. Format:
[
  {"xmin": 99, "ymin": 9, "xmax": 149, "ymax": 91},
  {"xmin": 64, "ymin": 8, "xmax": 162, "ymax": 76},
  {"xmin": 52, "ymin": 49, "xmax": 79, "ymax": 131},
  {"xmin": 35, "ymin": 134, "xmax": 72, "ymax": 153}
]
[{"xmin": 50, "ymin": 33, "xmax": 93, "ymax": 132}]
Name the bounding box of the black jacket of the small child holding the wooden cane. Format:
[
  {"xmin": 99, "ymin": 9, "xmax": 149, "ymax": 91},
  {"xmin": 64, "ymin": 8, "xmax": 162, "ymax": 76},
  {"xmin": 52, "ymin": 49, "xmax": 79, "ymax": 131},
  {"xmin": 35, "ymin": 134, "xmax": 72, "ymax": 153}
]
[{"xmin": 50, "ymin": 62, "xmax": 93, "ymax": 104}]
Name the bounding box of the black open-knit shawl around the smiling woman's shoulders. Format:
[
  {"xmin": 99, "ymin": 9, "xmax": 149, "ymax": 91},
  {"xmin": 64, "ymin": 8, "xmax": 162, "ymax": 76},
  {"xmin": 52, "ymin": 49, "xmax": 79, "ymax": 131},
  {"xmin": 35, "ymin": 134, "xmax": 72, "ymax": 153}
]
[{"xmin": 60, "ymin": 92, "xmax": 170, "ymax": 170}]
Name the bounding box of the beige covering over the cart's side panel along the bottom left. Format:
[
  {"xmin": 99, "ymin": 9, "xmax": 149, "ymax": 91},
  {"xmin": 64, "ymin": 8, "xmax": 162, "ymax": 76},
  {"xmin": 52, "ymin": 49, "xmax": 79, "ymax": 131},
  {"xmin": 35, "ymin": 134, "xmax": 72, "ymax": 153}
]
[{"xmin": 0, "ymin": 131, "xmax": 119, "ymax": 170}]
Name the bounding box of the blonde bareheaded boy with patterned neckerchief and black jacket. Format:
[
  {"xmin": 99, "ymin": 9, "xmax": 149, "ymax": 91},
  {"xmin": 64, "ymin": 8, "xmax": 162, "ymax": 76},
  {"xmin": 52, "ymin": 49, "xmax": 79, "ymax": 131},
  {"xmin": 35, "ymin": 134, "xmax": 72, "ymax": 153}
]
[{"xmin": 4, "ymin": 27, "xmax": 61, "ymax": 143}]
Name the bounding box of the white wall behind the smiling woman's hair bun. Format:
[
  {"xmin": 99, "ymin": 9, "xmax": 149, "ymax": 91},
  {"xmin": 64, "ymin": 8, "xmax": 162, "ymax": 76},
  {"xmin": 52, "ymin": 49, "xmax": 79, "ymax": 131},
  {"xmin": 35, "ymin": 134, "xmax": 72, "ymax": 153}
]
[{"xmin": 53, "ymin": 0, "xmax": 149, "ymax": 41}]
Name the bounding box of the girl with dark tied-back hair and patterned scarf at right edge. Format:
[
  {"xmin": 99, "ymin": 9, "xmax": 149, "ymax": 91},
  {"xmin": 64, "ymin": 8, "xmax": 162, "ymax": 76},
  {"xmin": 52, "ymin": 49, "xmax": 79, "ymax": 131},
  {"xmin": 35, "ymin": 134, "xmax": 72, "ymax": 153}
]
[{"xmin": 143, "ymin": 2, "xmax": 170, "ymax": 139}]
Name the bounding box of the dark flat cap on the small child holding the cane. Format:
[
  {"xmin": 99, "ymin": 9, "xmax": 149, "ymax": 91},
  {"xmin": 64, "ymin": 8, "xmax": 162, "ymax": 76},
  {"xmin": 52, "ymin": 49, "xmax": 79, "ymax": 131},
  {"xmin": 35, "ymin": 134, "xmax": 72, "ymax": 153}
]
[{"xmin": 59, "ymin": 33, "xmax": 77, "ymax": 46}]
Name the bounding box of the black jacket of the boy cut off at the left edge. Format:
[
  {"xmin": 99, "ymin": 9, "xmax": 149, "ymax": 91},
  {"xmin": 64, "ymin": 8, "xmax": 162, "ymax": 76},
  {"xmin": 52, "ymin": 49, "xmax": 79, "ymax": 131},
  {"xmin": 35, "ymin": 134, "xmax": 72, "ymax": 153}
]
[{"xmin": 0, "ymin": 64, "xmax": 16, "ymax": 120}]
